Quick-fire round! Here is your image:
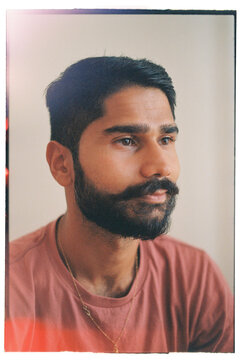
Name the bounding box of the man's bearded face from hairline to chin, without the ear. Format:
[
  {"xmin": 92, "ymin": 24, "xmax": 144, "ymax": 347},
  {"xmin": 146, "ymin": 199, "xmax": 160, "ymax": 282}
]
[{"xmin": 75, "ymin": 86, "xmax": 179, "ymax": 239}]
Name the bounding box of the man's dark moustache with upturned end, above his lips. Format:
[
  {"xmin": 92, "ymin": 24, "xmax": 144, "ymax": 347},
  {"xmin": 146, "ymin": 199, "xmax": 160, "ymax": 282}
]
[{"xmin": 111, "ymin": 178, "xmax": 179, "ymax": 201}]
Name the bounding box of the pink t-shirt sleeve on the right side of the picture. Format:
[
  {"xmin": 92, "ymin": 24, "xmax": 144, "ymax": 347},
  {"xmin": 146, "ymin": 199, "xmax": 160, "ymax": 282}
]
[{"xmin": 189, "ymin": 254, "xmax": 234, "ymax": 352}]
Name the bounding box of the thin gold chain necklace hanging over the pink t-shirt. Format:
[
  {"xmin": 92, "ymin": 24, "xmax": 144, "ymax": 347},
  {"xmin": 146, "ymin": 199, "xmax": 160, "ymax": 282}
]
[{"xmin": 59, "ymin": 235, "xmax": 138, "ymax": 353}]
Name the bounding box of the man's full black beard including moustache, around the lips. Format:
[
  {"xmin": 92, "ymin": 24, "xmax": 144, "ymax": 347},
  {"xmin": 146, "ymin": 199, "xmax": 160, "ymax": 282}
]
[{"xmin": 74, "ymin": 160, "xmax": 179, "ymax": 240}]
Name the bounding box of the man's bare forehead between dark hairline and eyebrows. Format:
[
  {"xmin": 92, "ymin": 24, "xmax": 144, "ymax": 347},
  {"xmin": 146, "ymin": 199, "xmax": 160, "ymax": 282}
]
[{"xmin": 82, "ymin": 86, "xmax": 174, "ymax": 136}]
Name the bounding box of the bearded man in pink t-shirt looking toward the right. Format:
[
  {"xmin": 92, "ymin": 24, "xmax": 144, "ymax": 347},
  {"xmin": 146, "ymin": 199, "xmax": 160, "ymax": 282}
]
[{"xmin": 5, "ymin": 57, "xmax": 233, "ymax": 353}]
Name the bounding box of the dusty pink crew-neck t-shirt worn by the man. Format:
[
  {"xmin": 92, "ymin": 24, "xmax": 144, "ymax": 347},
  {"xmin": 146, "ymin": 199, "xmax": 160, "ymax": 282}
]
[{"xmin": 5, "ymin": 221, "xmax": 233, "ymax": 353}]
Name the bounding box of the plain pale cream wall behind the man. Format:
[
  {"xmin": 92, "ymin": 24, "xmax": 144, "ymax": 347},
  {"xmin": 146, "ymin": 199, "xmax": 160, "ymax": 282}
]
[{"xmin": 8, "ymin": 12, "xmax": 234, "ymax": 287}]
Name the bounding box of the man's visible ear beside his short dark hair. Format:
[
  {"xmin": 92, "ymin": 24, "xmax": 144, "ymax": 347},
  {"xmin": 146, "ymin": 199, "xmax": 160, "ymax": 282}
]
[{"xmin": 46, "ymin": 141, "xmax": 74, "ymax": 187}]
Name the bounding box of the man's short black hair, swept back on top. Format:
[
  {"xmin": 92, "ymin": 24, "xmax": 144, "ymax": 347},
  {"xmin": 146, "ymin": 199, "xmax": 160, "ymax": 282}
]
[{"xmin": 46, "ymin": 56, "xmax": 176, "ymax": 156}]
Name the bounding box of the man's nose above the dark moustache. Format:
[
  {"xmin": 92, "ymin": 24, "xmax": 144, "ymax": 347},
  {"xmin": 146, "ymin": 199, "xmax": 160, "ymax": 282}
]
[{"xmin": 140, "ymin": 144, "xmax": 172, "ymax": 178}]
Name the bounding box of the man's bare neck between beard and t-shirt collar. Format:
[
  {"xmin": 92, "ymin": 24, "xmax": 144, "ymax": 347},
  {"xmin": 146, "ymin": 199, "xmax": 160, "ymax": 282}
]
[{"xmin": 57, "ymin": 213, "xmax": 139, "ymax": 297}]
